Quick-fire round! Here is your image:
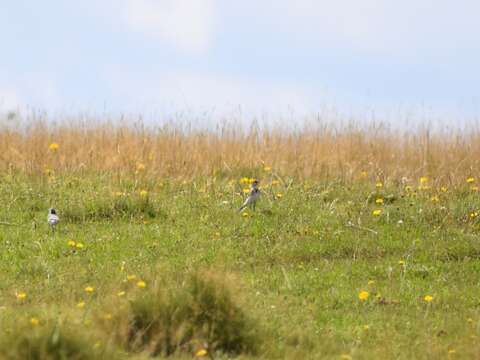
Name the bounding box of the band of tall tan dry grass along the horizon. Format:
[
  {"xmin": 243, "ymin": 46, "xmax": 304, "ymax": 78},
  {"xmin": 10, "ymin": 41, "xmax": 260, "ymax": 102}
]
[{"xmin": 0, "ymin": 112, "xmax": 480, "ymax": 182}]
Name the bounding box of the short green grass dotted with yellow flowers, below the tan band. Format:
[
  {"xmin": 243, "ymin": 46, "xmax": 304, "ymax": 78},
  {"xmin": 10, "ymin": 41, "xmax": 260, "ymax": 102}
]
[{"xmin": 0, "ymin": 173, "xmax": 480, "ymax": 359}]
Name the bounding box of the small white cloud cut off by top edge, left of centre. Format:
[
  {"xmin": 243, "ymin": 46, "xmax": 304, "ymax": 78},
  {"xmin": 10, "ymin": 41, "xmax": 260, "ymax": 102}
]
[{"xmin": 125, "ymin": 0, "xmax": 214, "ymax": 52}]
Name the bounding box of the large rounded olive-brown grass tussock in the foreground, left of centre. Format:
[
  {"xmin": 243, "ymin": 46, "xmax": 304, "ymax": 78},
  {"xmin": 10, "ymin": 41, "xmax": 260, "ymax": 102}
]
[{"xmin": 109, "ymin": 275, "xmax": 259, "ymax": 356}]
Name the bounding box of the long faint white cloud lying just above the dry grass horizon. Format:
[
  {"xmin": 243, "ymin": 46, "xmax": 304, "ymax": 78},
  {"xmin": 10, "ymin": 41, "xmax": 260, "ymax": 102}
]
[{"xmin": 106, "ymin": 68, "xmax": 326, "ymax": 114}]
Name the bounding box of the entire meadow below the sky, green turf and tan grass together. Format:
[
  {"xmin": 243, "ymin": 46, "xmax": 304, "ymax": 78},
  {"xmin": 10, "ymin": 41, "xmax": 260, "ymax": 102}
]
[{"xmin": 0, "ymin": 119, "xmax": 480, "ymax": 360}]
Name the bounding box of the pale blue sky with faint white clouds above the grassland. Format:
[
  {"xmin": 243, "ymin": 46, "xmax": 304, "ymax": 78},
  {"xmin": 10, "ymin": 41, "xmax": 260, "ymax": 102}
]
[{"xmin": 0, "ymin": 0, "xmax": 480, "ymax": 122}]
